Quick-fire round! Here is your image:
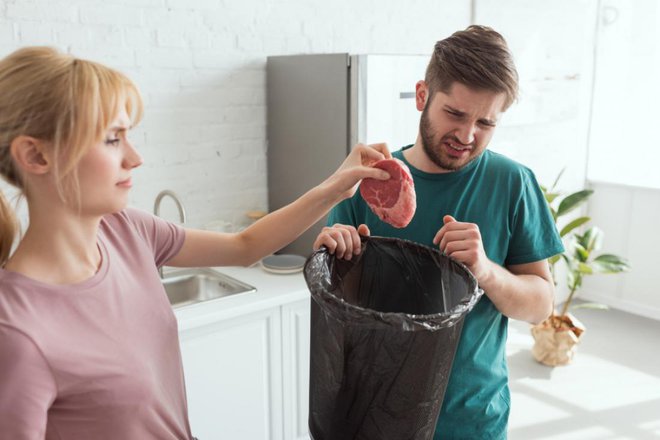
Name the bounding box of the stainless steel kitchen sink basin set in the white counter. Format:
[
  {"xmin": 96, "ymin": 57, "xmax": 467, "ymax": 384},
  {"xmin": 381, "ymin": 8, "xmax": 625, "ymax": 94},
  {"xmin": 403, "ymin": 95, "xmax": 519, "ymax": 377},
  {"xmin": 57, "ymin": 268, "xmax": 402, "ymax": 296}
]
[{"xmin": 161, "ymin": 268, "xmax": 257, "ymax": 308}]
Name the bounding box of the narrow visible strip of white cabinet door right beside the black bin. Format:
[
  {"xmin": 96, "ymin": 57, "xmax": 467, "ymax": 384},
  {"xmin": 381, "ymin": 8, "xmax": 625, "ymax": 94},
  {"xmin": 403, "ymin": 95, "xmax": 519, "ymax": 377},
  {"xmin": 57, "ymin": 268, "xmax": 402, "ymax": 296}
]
[{"xmin": 282, "ymin": 298, "xmax": 310, "ymax": 440}]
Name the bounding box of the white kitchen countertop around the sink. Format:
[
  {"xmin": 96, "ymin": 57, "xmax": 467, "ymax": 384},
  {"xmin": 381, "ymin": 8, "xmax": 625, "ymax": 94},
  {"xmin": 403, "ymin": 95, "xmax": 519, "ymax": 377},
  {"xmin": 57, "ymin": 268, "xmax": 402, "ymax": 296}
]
[{"xmin": 174, "ymin": 264, "xmax": 309, "ymax": 332}]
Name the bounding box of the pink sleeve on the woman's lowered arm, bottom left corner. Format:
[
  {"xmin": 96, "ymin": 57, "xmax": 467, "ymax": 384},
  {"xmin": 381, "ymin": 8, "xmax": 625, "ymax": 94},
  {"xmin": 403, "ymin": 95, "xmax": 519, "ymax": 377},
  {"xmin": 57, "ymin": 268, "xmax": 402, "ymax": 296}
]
[{"xmin": 0, "ymin": 323, "xmax": 57, "ymax": 439}]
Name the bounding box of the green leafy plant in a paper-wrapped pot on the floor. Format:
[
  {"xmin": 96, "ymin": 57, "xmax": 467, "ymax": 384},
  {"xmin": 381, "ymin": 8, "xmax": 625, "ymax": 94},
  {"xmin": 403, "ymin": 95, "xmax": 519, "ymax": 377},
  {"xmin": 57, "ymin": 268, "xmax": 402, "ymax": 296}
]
[{"xmin": 532, "ymin": 170, "xmax": 630, "ymax": 366}]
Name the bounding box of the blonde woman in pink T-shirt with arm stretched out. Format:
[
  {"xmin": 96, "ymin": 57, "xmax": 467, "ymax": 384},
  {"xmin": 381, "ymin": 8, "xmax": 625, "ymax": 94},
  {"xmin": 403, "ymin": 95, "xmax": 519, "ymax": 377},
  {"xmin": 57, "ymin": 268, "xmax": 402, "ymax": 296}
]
[{"xmin": 0, "ymin": 47, "xmax": 389, "ymax": 440}]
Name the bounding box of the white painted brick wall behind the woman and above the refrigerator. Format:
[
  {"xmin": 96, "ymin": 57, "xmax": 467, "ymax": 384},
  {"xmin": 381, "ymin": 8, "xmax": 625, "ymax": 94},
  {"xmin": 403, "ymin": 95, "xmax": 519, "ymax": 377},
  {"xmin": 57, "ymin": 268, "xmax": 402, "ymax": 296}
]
[{"xmin": 0, "ymin": 0, "xmax": 470, "ymax": 230}]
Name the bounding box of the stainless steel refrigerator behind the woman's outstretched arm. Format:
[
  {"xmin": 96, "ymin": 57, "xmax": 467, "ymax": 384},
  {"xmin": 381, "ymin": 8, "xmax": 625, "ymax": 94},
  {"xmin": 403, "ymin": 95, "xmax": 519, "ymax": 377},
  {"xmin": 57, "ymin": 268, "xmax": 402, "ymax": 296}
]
[{"xmin": 266, "ymin": 53, "xmax": 430, "ymax": 256}]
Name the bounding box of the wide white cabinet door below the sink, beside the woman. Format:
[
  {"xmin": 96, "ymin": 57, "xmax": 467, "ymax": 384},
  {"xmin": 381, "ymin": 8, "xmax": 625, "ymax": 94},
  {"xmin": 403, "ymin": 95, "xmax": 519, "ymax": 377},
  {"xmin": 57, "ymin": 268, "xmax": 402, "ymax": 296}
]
[{"xmin": 180, "ymin": 307, "xmax": 282, "ymax": 440}]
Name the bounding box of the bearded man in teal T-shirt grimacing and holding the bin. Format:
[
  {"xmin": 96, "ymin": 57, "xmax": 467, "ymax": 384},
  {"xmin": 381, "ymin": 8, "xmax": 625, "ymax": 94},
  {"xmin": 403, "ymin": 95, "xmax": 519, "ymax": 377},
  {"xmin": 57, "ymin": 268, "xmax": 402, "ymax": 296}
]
[{"xmin": 316, "ymin": 26, "xmax": 563, "ymax": 440}]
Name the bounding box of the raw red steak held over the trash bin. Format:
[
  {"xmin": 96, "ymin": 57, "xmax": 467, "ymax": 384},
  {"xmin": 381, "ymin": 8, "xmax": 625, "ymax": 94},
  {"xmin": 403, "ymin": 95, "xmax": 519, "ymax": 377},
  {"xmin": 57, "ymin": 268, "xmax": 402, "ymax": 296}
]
[{"xmin": 360, "ymin": 158, "xmax": 417, "ymax": 228}]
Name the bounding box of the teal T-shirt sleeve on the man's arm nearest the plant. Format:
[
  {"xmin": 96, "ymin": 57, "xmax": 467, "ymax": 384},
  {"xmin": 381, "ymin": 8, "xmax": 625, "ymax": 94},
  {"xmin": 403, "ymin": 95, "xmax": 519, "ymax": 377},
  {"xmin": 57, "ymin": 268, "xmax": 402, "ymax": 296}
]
[{"xmin": 505, "ymin": 169, "xmax": 564, "ymax": 265}]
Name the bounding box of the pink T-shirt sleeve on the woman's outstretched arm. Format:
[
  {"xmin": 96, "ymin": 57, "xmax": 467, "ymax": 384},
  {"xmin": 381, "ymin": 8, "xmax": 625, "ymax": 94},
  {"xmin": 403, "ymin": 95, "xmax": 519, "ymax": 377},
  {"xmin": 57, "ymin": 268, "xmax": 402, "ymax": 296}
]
[{"xmin": 119, "ymin": 208, "xmax": 185, "ymax": 267}]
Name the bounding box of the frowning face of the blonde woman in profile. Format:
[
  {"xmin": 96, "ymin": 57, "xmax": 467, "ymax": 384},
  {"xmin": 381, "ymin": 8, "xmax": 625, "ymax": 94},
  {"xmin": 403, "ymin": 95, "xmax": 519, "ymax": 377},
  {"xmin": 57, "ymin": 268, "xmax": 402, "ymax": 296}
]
[{"xmin": 78, "ymin": 108, "xmax": 142, "ymax": 215}]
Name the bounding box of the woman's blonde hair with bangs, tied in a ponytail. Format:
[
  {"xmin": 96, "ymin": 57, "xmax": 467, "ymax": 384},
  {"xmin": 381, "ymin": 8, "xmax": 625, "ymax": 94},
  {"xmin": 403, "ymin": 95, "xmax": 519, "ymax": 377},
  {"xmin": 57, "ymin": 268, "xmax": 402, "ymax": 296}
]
[{"xmin": 0, "ymin": 47, "xmax": 143, "ymax": 265}]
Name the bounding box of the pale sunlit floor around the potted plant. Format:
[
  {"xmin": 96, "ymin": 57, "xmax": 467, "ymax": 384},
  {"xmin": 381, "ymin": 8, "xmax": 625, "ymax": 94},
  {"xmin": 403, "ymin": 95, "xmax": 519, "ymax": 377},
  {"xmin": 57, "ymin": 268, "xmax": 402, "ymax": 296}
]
[{"xmin": 507, "ymin": 309, "xmax": 660, "ymax": 440}]
